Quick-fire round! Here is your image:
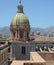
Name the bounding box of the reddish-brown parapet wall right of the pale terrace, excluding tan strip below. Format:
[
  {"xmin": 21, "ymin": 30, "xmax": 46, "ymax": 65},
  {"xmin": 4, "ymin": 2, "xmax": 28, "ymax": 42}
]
[{"xmin": 39, "ymin": 52, "xmax": 54, "ymax": 61}]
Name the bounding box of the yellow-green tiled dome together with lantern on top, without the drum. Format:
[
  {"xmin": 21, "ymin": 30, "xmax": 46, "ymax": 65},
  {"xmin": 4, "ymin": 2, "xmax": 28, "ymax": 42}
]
[{"xmin": 11, "ymin": 1, "xmax": 29, "ymax": 26}]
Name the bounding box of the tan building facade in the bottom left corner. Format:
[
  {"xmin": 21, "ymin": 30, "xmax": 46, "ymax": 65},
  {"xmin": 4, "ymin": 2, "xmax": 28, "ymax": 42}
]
[{"xmin": 0, "ymin": 46, "xmax": 8, "ymax": 65}]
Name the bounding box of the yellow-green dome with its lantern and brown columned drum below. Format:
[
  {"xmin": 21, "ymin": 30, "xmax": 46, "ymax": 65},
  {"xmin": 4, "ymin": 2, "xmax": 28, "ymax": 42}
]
[{"xmin": 10, "ymin": 0, "xmax": 30, "ymax": 42}]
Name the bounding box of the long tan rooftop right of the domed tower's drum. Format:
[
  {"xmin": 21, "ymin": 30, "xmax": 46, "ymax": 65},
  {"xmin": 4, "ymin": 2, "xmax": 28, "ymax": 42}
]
[{"xmin": 35, "ymin": 35, "xmax": 54, "ymax": 43}]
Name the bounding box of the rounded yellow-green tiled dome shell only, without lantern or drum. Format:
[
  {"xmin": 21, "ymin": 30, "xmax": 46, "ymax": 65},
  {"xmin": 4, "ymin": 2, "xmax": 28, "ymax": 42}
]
[{"xmin": 11, "ymin": 13, "xmax": 29, "ymax": 26}]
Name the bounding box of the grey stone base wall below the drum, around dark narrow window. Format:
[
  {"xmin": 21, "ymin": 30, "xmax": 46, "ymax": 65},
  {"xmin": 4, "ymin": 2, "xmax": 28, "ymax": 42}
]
[{"xmin": 11, "ymin": 43, "xmax": 35, "ymax": 60}]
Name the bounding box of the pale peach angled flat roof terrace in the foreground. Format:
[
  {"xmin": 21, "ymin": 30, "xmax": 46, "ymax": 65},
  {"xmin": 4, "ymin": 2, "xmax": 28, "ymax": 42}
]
[{"xmin": 11, "ymin": 52, "xmax": 45, "ymax": 65}]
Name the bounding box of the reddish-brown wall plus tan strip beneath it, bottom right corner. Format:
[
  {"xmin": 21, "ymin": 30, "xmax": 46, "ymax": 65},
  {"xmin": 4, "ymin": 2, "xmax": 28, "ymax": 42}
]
[{"xmin": 39, "ymin": 52, "xmax": 54, "ymax": 65}]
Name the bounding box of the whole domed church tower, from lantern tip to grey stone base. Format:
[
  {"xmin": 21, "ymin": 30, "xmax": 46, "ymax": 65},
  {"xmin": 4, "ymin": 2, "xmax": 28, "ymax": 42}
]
[{"xmin": 10, "ymin": 1, "xmax": 35, "ymax": 60}]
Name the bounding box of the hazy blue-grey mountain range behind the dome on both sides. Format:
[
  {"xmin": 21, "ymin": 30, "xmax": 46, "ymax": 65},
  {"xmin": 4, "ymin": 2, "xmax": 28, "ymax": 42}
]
[{"xmin": 0, "ymin": 26, "xmax": 54, "ymax": 36}]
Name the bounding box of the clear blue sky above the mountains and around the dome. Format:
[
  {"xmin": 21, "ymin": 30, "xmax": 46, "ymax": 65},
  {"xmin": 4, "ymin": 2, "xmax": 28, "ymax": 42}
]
[{"xmin": 0, "ymin": 0, "xmax": 54, "ymax": 28}]
